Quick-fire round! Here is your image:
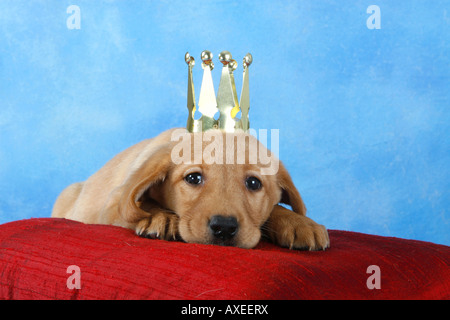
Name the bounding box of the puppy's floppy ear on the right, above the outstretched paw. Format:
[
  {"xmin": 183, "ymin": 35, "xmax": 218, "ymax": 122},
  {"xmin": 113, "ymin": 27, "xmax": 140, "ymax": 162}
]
[{"xmin": 277, "ymin": 161, "xmax": 306, "ymax": 216}]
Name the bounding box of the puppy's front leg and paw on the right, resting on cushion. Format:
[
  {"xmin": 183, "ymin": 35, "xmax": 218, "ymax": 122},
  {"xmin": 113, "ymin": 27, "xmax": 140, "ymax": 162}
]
[{"xmin": 263, "ymin": 205, "xmax": 330, "ymax": 250}]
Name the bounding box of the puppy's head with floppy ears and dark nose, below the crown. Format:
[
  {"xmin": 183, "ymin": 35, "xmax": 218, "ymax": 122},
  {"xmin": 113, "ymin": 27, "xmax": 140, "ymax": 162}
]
[{"xmin": 123, "ymin": 131, "xmax": 306, "ymax": 248}]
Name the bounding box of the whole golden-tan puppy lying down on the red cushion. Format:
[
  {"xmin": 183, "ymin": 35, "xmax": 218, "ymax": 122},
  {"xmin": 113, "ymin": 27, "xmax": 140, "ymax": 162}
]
[{"xmin": 52, "ymin": 129, "xmax": 330, "ymax": 250}]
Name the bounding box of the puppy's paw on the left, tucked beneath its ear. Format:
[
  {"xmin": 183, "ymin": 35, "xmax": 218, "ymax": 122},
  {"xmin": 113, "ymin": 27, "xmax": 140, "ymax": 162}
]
[{"xmin": 136, "ymin": 212, "xmax": 178, "ymax": 240}]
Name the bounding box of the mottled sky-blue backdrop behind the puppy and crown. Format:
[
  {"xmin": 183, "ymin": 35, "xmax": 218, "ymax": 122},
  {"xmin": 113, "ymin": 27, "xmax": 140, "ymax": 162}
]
[{"xmin": 0, "ymin": 0, "xmax": 450, "ymax": 245}]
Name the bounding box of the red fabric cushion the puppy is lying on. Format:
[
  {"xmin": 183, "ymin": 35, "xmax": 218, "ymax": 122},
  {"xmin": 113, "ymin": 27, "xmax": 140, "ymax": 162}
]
[{"xmin": 0, "ymin": 218, "xmax": 450, "ymax": 299}]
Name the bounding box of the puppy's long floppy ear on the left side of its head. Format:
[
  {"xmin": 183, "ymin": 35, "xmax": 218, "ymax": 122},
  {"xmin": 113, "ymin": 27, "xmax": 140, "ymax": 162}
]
[{"xmin": 119, "ymin": 143, "xmax": 172, "ymax": 223}]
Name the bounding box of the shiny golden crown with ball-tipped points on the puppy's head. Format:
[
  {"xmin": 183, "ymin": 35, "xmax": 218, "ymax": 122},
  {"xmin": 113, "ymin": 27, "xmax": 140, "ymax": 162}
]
[{"xmin": 184, "ymin": 50, "xmax": 253, "ymax": 132}]
